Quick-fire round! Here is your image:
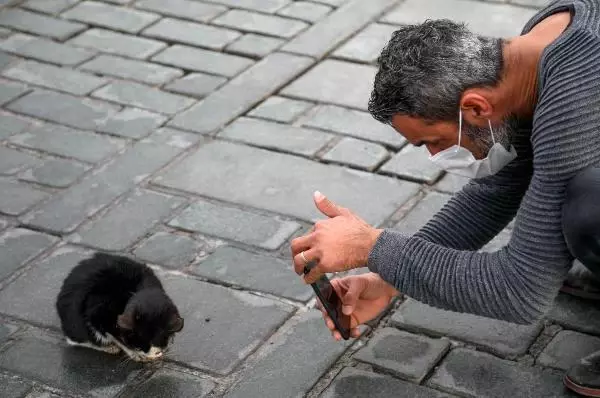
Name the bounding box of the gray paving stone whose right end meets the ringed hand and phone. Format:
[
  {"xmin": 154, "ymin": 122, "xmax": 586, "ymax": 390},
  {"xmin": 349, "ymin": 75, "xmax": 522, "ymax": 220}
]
[{"xmin": 191, "ymin": 246, "xmax": 313, "ymax": 302}]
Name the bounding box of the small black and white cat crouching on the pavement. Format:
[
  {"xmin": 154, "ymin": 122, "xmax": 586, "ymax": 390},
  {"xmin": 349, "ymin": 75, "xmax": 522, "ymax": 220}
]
[{"xmin": 56, "ymin": 253, "xmax": 184, "ymax": 362}]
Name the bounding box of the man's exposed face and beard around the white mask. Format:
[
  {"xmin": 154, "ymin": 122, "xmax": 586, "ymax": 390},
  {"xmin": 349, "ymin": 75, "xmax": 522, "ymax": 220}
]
[{"xmin": 392, "ymin": 114, "xmax": 517, "ymax": 159}]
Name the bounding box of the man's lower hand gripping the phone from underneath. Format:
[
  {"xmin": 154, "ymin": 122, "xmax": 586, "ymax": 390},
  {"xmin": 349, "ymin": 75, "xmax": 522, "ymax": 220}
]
[{"xmin": 317, "ymin": 272, "xmax": 399, "ymax": 341}]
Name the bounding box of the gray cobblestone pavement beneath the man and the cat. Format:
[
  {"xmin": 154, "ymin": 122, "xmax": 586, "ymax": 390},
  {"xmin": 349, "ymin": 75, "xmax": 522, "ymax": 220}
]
[{"xmin": 0, "ymin": 0, "xmax": 600, "ymax": 398}]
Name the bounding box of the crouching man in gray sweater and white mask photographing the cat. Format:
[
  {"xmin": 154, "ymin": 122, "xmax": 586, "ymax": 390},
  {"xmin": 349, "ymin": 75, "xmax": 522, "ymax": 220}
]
[{"xmin": 292, "ymin": 0, "xmax": 600, "ymax": 396}]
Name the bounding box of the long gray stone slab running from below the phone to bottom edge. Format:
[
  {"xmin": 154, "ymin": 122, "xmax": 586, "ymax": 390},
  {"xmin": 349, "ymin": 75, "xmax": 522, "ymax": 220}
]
[{"xmin": 225, "ymin": 310, "xmax": 351, "ymax": 398}]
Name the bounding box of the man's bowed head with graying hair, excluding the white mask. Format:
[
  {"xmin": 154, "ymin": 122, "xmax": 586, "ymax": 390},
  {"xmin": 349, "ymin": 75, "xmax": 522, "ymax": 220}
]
[{"xmin": 369, "ymin": 20, "xmax": 516, "ymax": 159}]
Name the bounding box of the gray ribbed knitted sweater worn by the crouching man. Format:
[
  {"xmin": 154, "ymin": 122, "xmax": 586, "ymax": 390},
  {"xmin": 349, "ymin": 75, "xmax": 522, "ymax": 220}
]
[{"xmin": 368, "ymin": 0, "xmax": 600, "ymax": 324}]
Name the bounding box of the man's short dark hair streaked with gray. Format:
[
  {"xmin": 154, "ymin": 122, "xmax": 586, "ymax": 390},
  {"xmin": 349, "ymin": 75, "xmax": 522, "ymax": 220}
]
[{"xmin": 369, "ymin": 19, "xmax": 503, "ymax": 124}]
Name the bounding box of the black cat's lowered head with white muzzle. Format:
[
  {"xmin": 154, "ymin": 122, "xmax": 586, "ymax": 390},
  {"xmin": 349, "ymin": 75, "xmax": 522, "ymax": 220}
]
[{"xmin": 117, "ymin": 289, "xmax": 183, "ymax": 361}]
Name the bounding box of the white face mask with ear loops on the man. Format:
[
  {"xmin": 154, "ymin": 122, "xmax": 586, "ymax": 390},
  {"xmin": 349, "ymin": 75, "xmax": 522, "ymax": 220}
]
[{"xmin": 429, "ymin": 110, "xmax": 517, "ymax": 178}]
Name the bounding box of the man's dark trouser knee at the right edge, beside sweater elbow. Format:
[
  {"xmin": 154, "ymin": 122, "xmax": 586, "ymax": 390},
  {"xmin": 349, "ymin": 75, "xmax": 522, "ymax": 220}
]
[{"xmin": 562, "ymin": 167, "xmax": 600, "ymax": 277}]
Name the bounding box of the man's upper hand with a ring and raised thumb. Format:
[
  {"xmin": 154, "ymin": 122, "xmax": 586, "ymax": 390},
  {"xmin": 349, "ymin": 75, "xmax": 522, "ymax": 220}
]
[{"xmin": 292, "ymin": 192, "xmax": 381, "ymax": 283}]
